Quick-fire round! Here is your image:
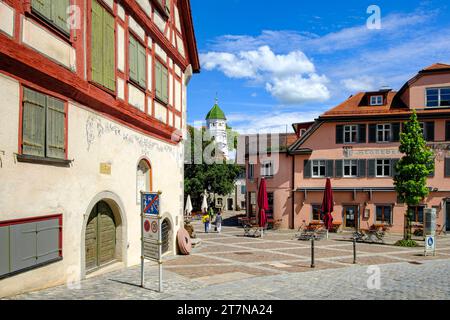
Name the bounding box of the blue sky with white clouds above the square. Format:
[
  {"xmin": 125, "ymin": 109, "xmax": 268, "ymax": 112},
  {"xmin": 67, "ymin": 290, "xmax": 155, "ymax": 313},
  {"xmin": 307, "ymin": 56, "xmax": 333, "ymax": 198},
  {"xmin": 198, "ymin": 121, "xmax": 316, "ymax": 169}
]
[{"xmin": 188, "ymin": 0, "xmax": 450, "ymax": 133}]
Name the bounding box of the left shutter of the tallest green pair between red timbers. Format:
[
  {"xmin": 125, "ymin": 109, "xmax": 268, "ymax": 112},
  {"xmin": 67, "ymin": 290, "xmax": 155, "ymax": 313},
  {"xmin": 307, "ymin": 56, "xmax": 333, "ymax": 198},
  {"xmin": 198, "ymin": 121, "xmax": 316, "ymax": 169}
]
[{"xmin": 91, "ymin": 1, "xmax": 103, "ymax": 84}]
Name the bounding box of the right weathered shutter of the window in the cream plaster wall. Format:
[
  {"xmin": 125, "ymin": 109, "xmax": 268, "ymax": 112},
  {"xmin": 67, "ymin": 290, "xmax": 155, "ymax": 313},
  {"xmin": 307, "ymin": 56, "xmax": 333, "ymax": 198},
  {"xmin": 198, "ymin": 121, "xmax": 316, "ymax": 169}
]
[{"xmin": 46, "ymin": 97, "xmax": 66, "ymax": 159}]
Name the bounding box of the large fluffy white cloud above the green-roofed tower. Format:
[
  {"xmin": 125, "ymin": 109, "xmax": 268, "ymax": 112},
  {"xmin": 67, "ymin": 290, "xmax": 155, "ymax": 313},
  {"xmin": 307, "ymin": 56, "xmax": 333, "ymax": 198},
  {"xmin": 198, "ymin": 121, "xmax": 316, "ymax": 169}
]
[{"xmin": 200, "ymin": 46, "xmax": 330, "ymax": 104}]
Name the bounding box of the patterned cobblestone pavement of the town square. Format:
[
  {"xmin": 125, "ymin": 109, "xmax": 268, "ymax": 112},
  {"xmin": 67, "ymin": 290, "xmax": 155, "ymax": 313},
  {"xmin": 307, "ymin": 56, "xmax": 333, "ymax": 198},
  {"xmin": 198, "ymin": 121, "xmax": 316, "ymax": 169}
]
[{"xmin": 7, "ymin": 218, "xmax": 450, "ymax": 300}]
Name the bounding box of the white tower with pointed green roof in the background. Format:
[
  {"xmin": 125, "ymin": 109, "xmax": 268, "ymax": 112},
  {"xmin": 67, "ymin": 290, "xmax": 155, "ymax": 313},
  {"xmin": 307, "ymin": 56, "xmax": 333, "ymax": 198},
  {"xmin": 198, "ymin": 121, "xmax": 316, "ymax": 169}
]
[{"xmin": 206, "ymin": 98, "xmax": 228, "ymax": 158}]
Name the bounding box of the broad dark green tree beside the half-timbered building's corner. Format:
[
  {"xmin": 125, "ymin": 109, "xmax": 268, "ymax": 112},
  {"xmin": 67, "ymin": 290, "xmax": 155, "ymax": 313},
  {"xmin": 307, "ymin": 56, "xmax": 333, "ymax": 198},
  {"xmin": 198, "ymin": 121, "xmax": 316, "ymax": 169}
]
[{"xmin": 184, "ymin": 126, "xmax": 243, "ymax": 210}]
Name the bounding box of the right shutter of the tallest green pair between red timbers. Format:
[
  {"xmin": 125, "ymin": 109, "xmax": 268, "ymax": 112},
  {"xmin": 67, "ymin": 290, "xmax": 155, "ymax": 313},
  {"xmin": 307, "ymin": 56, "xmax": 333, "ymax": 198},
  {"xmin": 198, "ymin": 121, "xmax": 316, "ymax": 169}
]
[{"xmin": 102, "ymin": 9, "xmax": 116, "ymax": 91}]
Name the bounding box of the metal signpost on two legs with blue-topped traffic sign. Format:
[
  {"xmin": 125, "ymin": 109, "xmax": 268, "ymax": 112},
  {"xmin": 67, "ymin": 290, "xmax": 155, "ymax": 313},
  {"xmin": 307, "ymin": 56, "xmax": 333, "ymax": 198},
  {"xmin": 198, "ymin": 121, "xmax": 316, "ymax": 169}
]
[{"xmin": 141, "ymin": 192, "xmax": 163, "ymax": 292}]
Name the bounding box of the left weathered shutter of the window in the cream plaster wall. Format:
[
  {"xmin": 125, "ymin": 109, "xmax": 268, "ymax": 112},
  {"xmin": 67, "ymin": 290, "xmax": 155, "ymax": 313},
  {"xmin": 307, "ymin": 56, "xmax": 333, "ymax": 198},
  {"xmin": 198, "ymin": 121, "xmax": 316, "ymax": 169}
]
[{"xmin": 22, "ymin": 88, "xmax": 46, "ymax": 157}]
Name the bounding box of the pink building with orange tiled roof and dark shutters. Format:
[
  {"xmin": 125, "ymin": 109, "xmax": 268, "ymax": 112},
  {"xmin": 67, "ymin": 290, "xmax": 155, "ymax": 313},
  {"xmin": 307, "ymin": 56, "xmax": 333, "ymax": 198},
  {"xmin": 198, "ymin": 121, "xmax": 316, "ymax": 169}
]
[{"xmin": 247, "ymin": 64, "xmax": 450, "ymax": 233}]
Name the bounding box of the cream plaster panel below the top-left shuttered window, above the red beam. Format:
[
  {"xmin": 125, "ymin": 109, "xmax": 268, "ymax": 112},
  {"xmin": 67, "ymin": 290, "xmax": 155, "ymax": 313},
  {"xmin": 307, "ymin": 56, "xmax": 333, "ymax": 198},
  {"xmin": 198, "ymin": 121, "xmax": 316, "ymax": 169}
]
[{"xmin": 22, "ymin": 17, "xmax": 76, "ymax": 71}]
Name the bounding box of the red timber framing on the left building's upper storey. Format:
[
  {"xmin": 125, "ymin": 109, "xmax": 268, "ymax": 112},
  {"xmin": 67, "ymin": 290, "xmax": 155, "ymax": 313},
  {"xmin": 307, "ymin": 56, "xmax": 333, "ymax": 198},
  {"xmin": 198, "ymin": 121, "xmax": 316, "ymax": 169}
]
[{"xmin": 0, "ymin": 0, "xmax": 200, "ymax": 144}]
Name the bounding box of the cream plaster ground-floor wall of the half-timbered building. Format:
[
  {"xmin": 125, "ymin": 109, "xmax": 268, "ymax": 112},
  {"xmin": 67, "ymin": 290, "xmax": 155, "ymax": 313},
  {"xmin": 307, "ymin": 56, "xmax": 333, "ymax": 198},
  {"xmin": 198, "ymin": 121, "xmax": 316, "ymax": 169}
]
[{"xmin": 0, "ymin": 76, "xmax": 183, "ymax": 297}]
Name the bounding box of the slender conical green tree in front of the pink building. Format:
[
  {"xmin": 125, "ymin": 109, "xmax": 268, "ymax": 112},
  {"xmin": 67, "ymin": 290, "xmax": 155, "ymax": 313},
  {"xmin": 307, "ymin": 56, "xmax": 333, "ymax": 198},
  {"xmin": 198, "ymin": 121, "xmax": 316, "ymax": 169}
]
[{"xmin": 394, "ymin": 111, "xmax": 434, "ymax": 241}]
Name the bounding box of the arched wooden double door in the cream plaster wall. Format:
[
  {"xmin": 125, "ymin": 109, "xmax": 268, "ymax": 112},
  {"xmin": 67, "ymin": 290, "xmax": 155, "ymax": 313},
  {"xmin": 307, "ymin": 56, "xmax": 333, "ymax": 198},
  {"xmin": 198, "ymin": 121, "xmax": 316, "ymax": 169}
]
[{"xmin": 85, "ymin": 201, "xmax": 116, "ymax": 271}]
